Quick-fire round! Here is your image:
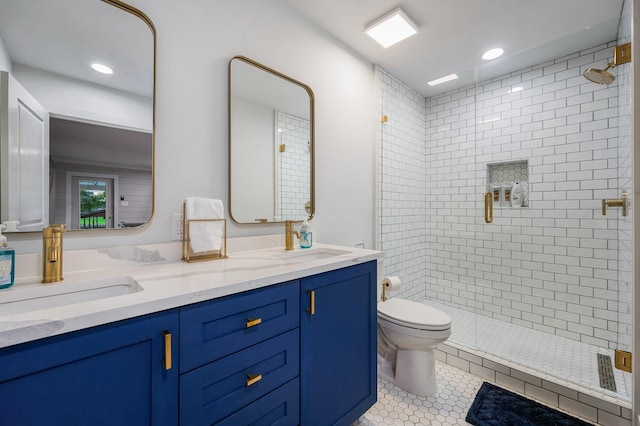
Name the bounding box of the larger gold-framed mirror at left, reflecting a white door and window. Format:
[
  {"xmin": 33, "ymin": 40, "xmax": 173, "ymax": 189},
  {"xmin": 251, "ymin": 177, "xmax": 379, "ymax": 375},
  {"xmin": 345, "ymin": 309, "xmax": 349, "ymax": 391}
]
[{"xmin": 0, "ymin": 0, "xmax": 155, "ymax": 231}]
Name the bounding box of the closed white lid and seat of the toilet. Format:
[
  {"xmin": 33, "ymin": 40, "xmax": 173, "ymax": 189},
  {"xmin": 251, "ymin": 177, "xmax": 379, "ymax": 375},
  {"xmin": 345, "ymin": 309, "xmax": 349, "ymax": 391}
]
[{"xmin": 378, "ymin": 297, "xmax": 451, "ymax": 330}]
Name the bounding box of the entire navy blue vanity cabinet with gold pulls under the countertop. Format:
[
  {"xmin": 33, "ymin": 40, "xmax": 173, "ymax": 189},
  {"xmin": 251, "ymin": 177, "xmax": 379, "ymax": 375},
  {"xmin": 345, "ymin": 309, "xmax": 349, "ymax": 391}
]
[{"xmin": 0, "ymin": 261, "xmax": 376, "ymax": 426}]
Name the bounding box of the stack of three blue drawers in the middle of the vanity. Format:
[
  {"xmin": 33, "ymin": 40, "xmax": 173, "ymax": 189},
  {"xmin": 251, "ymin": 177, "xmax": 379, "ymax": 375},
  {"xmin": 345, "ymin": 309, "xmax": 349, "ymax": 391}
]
[{"xmin": 179, "ymin": 281, "xmax": 300, "ymax": 426}]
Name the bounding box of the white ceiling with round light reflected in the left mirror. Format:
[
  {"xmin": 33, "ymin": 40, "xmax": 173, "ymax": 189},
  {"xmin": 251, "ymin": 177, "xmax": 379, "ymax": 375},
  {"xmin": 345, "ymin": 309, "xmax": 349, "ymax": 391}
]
[{"xmin": 0, "ymin": 0, "xmax": 154, "ymax": 97}]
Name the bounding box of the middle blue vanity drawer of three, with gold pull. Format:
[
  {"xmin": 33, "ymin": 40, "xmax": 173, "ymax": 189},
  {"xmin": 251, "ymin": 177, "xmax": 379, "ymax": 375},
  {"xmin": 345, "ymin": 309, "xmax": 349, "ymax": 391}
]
[{"xmin": 180, "ymin": 329, "xmax": 300, "ymax": 425}]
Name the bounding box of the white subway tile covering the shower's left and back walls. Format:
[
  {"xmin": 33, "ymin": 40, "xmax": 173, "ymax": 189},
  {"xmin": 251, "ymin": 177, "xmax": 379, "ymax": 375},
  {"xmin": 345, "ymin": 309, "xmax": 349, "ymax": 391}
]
[{"xmin": 379, "ymin": 42, "xmax": 631, "ymax": 348}]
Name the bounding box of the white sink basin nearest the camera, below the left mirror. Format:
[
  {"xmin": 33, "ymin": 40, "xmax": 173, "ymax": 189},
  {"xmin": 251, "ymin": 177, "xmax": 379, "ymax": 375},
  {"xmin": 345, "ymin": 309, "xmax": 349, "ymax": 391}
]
[{"xmin": 0, "ymin": 276, "xmax": 143, "ymax": 316}]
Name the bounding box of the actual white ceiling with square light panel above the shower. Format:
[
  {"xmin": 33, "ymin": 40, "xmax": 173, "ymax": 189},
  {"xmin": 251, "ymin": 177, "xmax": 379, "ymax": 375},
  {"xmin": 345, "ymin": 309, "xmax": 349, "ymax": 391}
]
[{"xmin": 283, "ymin": 0, "xmax": 624, "ymax": 97}]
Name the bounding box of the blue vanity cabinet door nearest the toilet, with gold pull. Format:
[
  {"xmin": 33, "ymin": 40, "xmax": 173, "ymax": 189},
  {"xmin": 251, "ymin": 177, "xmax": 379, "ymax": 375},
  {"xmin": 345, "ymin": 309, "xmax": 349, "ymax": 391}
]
[{"xmin": 300, "ymin": 261, "xmax": 377, "ymax": 426}]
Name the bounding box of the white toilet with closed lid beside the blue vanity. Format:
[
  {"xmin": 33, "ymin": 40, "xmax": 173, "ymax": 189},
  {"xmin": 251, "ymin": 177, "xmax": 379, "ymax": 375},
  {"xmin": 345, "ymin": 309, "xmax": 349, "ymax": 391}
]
[{"xmin": 378, "ymin": 297, "xmax": 451, "ymax": 396}]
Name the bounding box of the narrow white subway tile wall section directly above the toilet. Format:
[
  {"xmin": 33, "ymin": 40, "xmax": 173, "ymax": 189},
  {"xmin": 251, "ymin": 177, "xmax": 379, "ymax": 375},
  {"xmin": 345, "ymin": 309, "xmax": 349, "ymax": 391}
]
[{"xmin": 378, "ymin": 68, "xmax": 427, "ymax": 301}]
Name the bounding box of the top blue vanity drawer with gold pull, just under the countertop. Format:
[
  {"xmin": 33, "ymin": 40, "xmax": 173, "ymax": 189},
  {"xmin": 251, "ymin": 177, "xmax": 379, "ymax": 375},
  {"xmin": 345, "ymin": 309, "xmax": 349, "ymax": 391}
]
[{"xmin": 180, "ymin": 281, "xmax": 300, "ymax": 373}]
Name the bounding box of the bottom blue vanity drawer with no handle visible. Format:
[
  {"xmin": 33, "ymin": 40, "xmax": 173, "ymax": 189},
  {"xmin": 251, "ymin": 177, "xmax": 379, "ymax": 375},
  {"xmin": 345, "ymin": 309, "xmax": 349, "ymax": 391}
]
[{"xmin": 217, "ymin": 378, "xmax": 300, "ymax": 426}]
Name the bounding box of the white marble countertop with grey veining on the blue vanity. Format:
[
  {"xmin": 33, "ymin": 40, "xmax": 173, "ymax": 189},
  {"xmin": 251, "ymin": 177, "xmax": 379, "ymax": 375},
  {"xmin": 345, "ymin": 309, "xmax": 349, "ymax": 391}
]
[{"xmin": 0, "ymin": 240, "xmax": 383, "ymax": 348}]
